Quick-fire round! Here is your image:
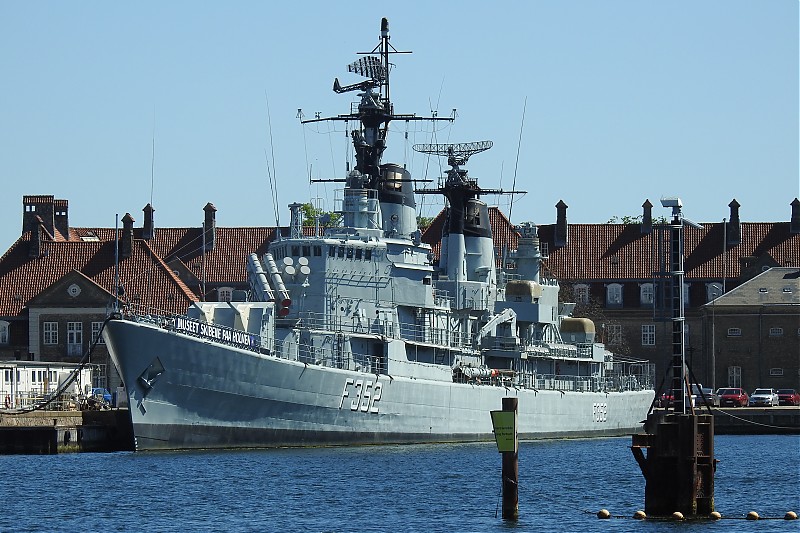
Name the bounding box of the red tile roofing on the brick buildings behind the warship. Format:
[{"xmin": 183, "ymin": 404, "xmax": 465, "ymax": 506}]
[{"xmin": 0, "ymin": 203, "xmax": 800, "ymax": 317}]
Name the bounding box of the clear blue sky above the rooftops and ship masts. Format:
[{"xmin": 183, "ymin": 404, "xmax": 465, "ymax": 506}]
[{"xmin": 0, "ymin": 0, "xmax": 800, "ymax": 253}]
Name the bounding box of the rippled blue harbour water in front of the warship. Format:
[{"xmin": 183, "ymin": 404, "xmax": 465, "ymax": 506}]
[{"xmin": 0, "ymin": 435, "xmax": 800, "ymax": 533}]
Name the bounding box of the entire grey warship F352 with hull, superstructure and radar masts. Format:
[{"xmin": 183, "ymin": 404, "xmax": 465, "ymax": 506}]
[{"xmin": 103, "ymin": 19, "xmax": 654, "ymax": 450}]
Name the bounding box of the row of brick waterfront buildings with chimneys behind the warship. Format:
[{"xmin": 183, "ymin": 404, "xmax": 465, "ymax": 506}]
[{"xmin": 0, "ymin": 196, "xmax": 800, "ymax": 390}]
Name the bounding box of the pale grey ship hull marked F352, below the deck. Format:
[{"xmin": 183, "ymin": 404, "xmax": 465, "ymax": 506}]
[{"xmin": 104, "ymin": 319, "xmax": 654, "ymax": 450}]
